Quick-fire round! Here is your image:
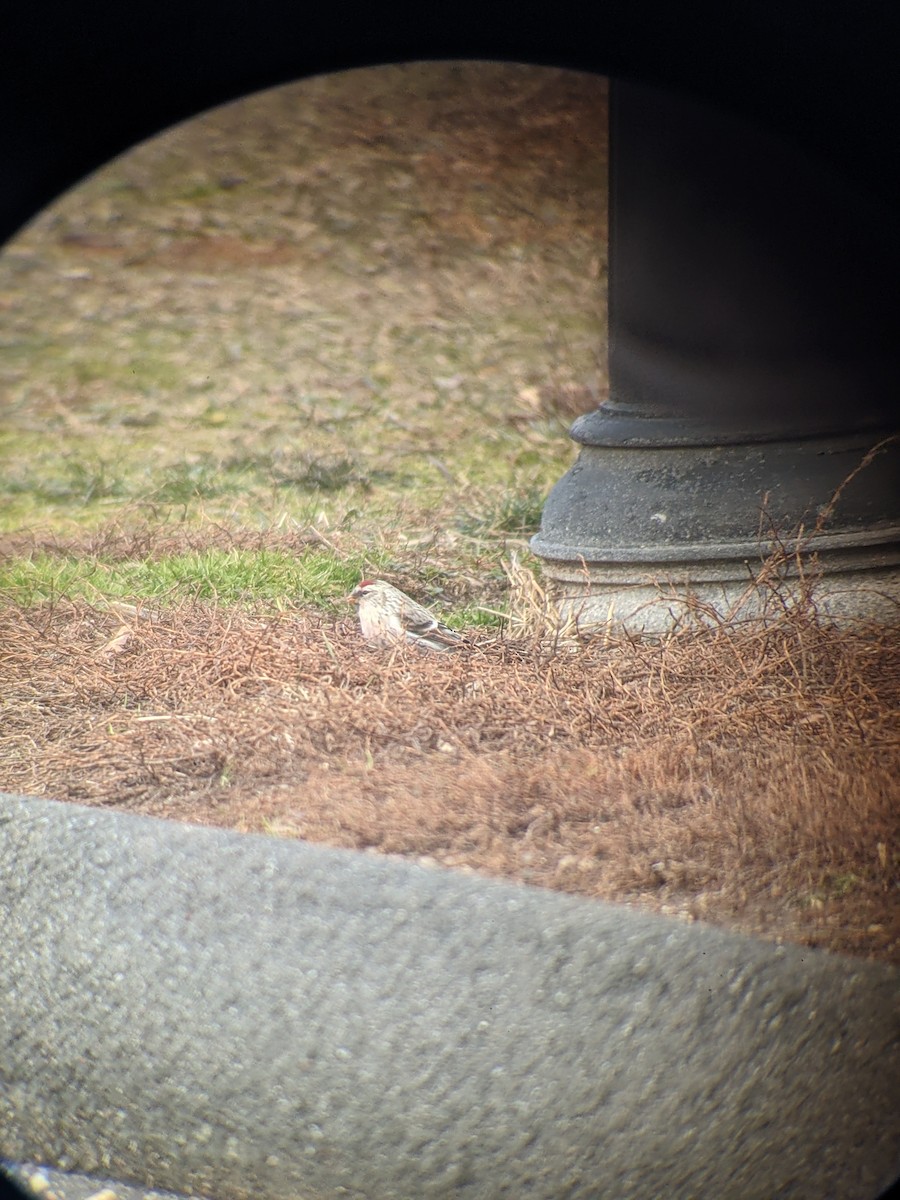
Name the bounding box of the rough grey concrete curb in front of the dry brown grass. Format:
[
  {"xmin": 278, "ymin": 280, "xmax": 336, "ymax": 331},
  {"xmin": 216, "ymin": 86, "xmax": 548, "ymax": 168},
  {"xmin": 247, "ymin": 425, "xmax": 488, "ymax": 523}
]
[{"xmin": 0, "ymin": 796, "xmax": 900, "ymax": 1200}]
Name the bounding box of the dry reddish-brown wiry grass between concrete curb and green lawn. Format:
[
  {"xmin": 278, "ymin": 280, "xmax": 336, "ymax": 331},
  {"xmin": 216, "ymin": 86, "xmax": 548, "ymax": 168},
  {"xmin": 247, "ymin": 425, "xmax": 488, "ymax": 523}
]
[{"xmin": 0, "ymin": 602, "xmax": 900, "ymax": 961}]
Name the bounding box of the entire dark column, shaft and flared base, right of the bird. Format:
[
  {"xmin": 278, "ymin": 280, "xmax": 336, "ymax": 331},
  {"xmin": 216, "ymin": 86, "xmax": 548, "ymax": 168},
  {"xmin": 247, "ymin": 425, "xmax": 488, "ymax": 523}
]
[{"xmin": 533, "ymin": 82, "xmax": 900, "ymax": 631}]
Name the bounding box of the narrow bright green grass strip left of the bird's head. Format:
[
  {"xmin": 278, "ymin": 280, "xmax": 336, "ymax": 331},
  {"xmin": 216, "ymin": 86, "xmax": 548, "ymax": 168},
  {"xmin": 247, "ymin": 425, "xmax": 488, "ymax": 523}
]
[{"xmin": 0, "ymin": 550, "xmax": 388, "ymax": 610}]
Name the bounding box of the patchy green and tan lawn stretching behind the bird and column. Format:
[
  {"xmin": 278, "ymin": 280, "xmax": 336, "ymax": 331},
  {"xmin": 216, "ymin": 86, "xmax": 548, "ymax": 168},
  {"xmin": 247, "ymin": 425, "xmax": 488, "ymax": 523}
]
[{"xmin": 0, "ymin": 66, "xmax": 606, "ymax": 609}]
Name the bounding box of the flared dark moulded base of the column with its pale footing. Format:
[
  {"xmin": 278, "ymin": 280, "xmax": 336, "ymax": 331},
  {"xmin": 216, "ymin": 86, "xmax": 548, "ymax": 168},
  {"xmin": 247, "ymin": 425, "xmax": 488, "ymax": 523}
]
[{"xmin": 532, "ymin": 434, "xmax": 900, "ymax": 634}]
